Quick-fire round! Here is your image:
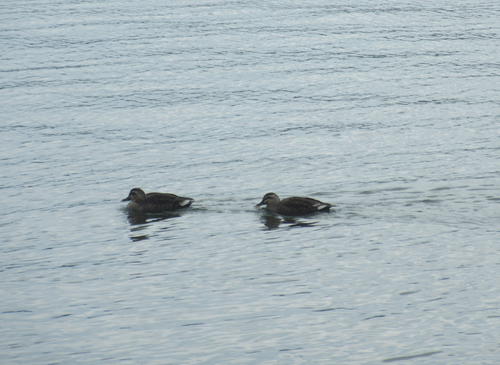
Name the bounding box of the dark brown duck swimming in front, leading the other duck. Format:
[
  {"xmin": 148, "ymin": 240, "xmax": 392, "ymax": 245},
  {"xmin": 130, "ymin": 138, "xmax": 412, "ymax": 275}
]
[{"xmin": 122, "ymin": 188, "xmax": 194, "ymax": 213}]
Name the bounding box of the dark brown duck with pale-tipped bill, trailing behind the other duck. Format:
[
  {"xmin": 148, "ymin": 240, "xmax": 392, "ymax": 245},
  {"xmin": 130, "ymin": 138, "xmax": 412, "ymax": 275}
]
[{"xmin": 255, "ymin": 193, "xmax": 333, "ymax": 215}]
